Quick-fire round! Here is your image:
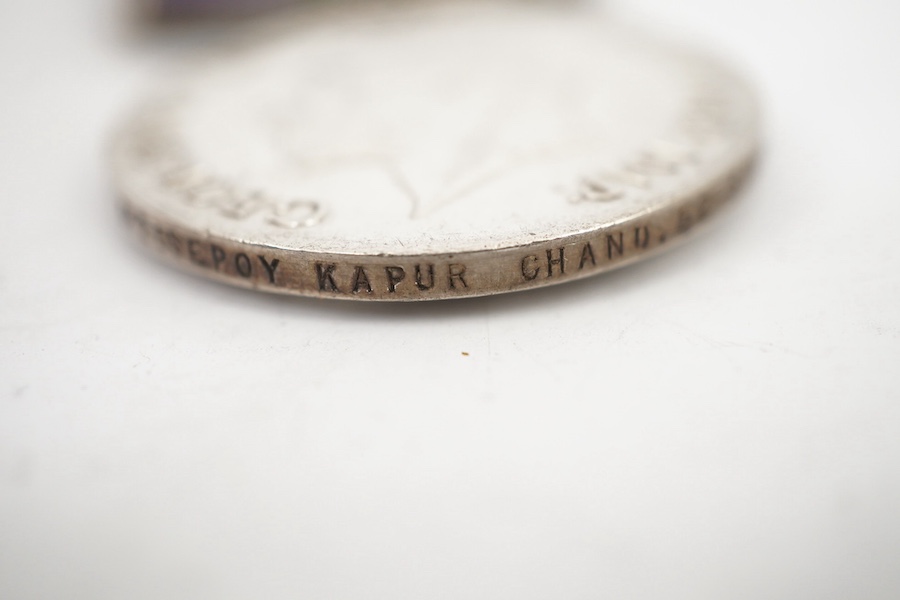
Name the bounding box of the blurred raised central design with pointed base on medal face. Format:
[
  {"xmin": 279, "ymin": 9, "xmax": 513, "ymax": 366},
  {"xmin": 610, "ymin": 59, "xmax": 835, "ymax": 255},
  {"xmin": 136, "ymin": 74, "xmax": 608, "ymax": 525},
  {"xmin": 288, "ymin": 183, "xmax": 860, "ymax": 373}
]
[{"xmin": 270, "ymin": 28, "xmax": 602, "ymax": 218}]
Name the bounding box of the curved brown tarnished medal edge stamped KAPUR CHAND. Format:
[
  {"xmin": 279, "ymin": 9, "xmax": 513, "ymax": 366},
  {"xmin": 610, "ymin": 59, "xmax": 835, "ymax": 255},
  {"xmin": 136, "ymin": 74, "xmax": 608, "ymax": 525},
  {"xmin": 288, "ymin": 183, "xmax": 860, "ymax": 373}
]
[{"xmin": 121, "ymin": 157, "xmax": 753, "ymax": 301}]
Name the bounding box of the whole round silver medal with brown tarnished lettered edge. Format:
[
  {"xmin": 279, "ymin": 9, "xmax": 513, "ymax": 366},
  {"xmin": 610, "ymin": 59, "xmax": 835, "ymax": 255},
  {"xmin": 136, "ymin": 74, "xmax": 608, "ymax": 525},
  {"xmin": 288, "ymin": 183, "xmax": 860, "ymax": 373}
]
[{"xmin": 114, "ymin": 2, "xmax": 757, "ymax": 300}]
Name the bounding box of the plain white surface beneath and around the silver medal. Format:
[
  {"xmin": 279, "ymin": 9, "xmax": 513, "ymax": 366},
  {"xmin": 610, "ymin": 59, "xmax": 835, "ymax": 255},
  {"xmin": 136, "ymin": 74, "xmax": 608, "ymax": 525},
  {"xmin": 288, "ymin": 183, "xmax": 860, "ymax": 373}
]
[{"xmin": 0, "ymin": 0, "xmax": 900, "ymax": 600}]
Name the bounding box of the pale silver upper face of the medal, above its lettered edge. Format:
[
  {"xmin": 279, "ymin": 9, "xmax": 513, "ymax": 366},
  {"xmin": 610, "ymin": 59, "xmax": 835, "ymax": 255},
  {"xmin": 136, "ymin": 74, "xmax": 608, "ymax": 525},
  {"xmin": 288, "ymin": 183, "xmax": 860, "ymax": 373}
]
[{"xmin": 116, "ymin": 4, "xmax": 756, "ymax": 252}]
